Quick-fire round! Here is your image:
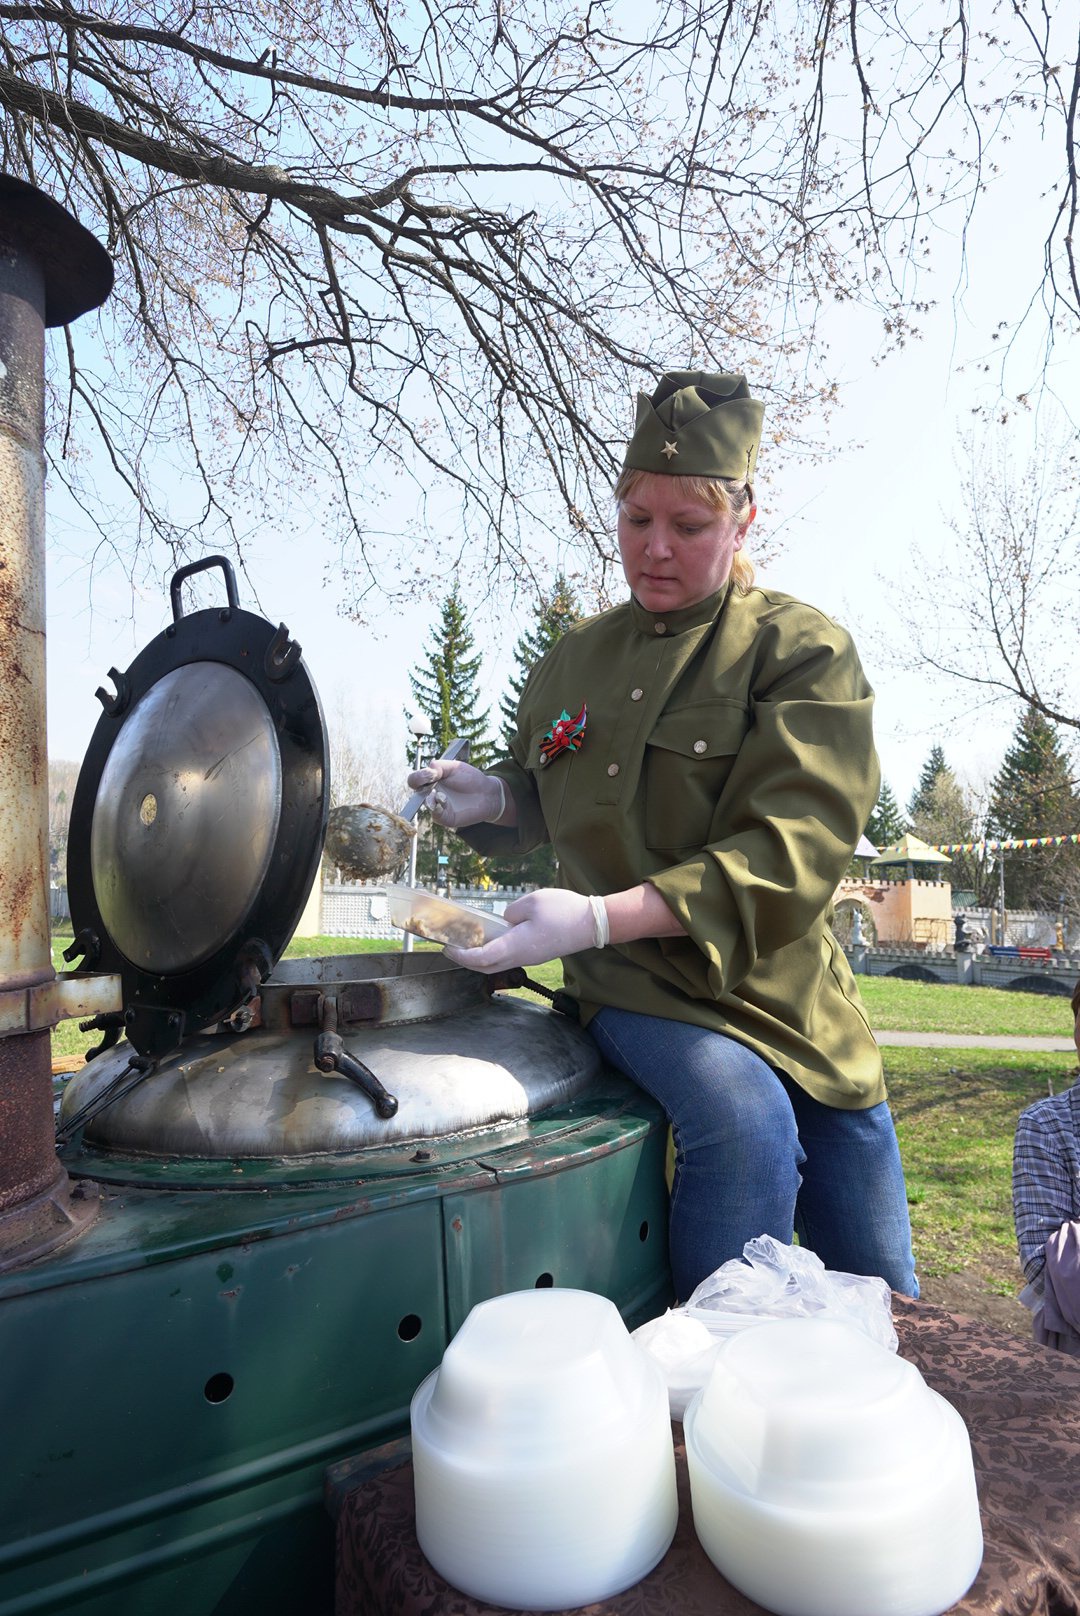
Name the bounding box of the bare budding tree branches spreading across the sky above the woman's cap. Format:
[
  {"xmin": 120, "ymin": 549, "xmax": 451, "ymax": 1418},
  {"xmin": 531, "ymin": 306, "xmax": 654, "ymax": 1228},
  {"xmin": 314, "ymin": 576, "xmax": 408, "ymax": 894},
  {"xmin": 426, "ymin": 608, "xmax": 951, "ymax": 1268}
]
[{"xmin": 0, "ymin": 0, "xmax": 1080, "ymax": 601}]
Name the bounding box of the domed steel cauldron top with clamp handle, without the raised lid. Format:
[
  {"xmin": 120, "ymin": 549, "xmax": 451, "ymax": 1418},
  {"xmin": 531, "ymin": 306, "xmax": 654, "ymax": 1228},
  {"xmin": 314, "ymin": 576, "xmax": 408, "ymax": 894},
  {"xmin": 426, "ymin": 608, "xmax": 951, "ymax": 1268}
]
[{"xmin": 60, "ymin": 953, "xmax": 601, "ymax": 1181}]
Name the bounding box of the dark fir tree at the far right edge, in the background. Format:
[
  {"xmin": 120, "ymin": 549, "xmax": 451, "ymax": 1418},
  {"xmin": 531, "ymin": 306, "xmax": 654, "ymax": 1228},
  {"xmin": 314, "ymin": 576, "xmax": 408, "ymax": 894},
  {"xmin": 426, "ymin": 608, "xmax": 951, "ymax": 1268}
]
[{"xmin": 988, "ymin": 706, "xmax": 1080, "ymax": 913}]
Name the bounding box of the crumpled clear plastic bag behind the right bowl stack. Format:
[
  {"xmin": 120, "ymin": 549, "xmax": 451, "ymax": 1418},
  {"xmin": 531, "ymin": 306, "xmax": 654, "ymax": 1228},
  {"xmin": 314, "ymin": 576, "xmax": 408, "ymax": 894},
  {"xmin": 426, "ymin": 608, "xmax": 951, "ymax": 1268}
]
[{"xmin": 634, "ymin": 1235, "xmax": 897, "ymax": 1419}]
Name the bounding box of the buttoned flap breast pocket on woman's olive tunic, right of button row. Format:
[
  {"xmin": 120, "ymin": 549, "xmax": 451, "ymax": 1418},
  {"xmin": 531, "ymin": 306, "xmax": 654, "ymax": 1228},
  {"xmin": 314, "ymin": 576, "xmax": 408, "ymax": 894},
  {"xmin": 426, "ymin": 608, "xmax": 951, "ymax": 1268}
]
[{"xmin": 645, "ymin": 701, "xmax": 750, "ymax": 853}]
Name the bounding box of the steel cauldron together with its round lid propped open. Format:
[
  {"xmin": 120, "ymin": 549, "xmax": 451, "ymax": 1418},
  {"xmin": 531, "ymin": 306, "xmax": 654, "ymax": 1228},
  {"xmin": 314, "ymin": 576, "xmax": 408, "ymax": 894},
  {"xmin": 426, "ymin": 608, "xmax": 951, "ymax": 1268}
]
[{"xmin": 60, "ymin": 556, "xmax": 620, "ymax": 1162}]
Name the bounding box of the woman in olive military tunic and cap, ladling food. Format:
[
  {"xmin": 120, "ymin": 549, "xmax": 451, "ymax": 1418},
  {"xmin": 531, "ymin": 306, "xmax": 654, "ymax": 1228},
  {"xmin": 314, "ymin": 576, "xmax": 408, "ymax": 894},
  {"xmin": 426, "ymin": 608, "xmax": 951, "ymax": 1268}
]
[{"xmin": 409, "ymin": 372, "xmax": 918, "ymax": 1299}]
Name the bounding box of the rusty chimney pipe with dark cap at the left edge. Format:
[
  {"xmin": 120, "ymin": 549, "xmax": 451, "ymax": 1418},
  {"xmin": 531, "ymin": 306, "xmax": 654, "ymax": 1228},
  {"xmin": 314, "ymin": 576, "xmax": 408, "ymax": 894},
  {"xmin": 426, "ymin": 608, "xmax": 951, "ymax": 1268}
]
[{"xmin": 0, "ymin": 175, "xmax": 113, "ymax": 1270}]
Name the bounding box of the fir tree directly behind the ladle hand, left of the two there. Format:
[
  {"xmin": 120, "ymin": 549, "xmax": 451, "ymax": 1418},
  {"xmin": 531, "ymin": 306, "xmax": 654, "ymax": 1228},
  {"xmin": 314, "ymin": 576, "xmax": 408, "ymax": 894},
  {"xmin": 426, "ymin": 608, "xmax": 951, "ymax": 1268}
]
[{"xmin": 409, "ymin": 583, "xmax": 495, "ymax": 886}]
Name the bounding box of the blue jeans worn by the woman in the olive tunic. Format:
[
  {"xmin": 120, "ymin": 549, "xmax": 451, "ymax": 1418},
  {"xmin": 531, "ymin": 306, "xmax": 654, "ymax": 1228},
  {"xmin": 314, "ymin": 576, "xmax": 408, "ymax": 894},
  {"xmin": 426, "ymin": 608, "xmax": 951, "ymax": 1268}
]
[{"xmin": 589, "ymin": 1008, "xmax": 918, "ymax": 1302}]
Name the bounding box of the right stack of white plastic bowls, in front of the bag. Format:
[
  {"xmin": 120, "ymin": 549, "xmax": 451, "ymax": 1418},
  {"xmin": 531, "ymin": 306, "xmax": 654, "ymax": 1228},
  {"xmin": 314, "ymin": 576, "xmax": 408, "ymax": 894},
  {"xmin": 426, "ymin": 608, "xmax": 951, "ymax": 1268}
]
[{"xmin": 684, "ymin": 1319, "xmax": 983, "ymax": 1616}]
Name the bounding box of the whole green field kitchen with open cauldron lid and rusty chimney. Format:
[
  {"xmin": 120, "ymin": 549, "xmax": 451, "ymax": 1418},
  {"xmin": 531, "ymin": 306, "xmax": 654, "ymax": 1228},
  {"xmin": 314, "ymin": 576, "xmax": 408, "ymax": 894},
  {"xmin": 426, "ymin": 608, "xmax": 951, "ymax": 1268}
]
[{"xmin": 0, "ymin": 176, "xmax": 669, "ymax": 1616}]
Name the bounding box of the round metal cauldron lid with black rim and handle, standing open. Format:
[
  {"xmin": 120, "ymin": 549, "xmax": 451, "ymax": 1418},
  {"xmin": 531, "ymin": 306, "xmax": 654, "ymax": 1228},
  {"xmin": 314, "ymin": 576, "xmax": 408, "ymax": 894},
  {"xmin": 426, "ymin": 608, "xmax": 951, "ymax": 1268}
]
[{"xmin": 68, "ymin": 556, "xmax": 330, "ymax": 1058}]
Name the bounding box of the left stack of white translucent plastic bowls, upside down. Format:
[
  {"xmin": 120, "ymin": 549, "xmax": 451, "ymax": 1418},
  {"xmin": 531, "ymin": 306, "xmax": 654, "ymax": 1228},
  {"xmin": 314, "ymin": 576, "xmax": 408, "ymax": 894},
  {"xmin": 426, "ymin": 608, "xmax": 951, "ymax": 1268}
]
[{"xmin": 412, "ymin": 1290, "xmax": 679, "ymax": 1610}]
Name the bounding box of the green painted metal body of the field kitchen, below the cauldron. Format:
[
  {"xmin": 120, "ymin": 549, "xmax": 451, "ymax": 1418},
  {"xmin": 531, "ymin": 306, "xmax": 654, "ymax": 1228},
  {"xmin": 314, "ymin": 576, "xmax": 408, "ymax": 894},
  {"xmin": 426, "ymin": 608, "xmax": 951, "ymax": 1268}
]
[{"xmin": 0, "ymin": 1075, "xmax": 669, "ymax": 1616}]
